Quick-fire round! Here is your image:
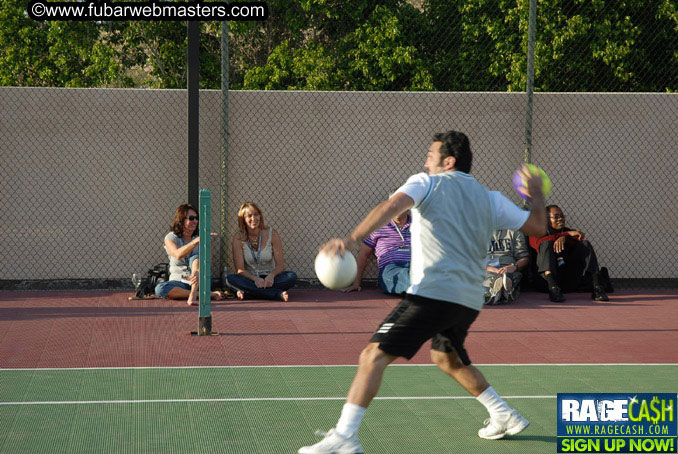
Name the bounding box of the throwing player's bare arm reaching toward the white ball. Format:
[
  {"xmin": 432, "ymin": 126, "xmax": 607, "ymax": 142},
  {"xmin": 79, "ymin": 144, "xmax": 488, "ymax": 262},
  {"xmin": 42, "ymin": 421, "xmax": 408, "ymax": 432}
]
[{"xmin": 320, "ymin": 192, "xmax": 414, "ymax": 257}]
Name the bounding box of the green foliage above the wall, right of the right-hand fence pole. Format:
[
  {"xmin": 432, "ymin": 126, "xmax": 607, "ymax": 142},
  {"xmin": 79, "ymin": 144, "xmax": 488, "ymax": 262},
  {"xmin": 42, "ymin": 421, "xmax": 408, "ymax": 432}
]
[{"xmin": 528, "ymin": 0, "xmax": 678, "ymax": 92}]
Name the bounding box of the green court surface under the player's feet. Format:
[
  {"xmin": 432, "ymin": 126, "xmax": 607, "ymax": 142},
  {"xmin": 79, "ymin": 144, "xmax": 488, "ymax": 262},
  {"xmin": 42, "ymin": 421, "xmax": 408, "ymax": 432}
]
[{"xmin": 0, "ymin": 364, "xmax": 678, "ymax": 454}]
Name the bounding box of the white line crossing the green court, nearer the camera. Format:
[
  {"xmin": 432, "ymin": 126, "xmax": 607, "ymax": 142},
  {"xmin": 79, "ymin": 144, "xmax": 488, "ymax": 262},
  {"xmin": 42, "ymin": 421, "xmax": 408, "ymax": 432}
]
[{"xmin": 0, "ymin": 396, "xmax": 556, "ymax": 406}]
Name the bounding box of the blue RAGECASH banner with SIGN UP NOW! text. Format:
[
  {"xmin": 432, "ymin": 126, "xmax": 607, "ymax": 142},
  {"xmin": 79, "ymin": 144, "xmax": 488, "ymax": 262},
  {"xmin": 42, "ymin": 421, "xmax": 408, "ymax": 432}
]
[{"xmin": 557, "ymin": 393, "xmax": 678, "ymax": 453}]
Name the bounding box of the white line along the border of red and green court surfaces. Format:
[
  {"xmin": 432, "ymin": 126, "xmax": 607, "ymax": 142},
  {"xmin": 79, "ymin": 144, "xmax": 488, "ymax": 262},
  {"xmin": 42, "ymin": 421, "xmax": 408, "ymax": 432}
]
[{"xmin": 0, "ymin": 363, "xmax": 678, "ymax": 372}]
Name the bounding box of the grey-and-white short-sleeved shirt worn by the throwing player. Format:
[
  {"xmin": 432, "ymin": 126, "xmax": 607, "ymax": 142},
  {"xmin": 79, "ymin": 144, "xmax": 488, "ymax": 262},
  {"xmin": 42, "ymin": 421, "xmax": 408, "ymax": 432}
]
[{"xmin": 396, "ymin": 171, "xmax": 530, "ymax": 310}]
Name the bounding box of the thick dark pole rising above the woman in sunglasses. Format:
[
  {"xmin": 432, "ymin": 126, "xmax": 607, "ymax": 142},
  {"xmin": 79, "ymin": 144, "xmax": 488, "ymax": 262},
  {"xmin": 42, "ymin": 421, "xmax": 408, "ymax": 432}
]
[{"xmin": 187, "ymin": 21, "xmax": 202, "ymax": 207}]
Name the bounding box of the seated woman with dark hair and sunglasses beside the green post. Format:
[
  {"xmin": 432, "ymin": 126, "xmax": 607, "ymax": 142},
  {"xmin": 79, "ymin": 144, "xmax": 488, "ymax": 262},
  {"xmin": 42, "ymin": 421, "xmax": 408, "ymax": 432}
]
[{"xmin": 155, "ymin": 203, "xmax": 224, "ymax": 306}]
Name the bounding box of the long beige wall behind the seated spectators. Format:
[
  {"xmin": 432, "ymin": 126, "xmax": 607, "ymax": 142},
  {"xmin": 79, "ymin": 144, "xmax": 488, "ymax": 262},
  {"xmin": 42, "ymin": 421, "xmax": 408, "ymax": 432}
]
[{"xmin": 0, "ymin": 87, "xmax": 678, "ymax": 280}]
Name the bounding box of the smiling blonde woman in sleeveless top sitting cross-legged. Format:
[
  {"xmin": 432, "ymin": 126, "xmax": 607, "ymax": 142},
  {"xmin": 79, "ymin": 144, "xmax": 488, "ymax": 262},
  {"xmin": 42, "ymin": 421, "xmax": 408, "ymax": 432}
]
[{"xmin": 226, "ymin": 202, "xmax": 297, "ymax": 301}]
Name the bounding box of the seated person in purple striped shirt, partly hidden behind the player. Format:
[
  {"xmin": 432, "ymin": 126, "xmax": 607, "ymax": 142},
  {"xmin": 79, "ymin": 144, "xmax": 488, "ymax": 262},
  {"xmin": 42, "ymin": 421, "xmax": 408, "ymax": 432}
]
[{"xmin": 343, "ymin": 210, "xmax": 412, "ymax": 295}]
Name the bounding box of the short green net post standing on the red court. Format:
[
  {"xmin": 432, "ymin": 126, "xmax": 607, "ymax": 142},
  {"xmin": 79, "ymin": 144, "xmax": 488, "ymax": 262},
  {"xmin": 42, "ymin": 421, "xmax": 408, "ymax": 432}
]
[{"xmin": 198, "ymin": 189, "xmax": 212, "ymax": 336}]
